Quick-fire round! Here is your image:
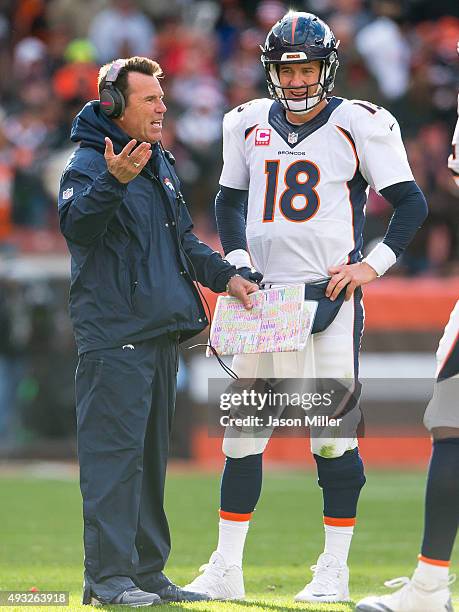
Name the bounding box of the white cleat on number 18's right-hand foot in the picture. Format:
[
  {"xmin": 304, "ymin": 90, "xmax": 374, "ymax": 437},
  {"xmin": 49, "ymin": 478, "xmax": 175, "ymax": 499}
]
[{"xmin": 295, "ymin": 553, "xmax": 350, "ymax": 603}]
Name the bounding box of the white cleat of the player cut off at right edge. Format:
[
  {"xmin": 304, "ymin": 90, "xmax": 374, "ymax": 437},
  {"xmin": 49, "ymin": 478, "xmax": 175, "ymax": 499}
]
[{"xmin": 355, "ymin": 570, "xmax": 456, "ymax": 612}]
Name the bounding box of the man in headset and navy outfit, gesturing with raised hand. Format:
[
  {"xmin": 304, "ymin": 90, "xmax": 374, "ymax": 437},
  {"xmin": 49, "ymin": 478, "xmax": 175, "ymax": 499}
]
[{"xmin": 59, "ymin": 57, "xmax": 258, "ymax": 607}]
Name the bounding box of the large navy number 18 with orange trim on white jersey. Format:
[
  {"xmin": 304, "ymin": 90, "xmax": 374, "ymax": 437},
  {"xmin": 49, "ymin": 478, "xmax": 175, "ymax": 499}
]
[{"xmin": 263, "ymin": 159, "xmax": 320, "ymax": 223}]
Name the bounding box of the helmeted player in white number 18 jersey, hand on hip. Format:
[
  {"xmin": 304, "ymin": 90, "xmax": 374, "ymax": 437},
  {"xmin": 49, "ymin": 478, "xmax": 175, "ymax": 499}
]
[{"xmin": 186, "ymin": 11, "xmax": 427, "ymax": 602}]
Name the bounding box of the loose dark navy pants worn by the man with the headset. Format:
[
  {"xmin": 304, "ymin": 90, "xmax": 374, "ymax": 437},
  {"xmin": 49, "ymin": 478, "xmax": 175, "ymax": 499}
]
[{"xmin": 76, "ymin": 335, "xmax": 178, "ymax": 583}]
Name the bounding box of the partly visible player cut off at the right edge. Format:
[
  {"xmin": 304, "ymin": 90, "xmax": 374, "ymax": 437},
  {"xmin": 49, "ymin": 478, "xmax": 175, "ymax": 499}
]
[{"xmin": 357, "ymin": 89, "xmax": 459, "ymax": 612}]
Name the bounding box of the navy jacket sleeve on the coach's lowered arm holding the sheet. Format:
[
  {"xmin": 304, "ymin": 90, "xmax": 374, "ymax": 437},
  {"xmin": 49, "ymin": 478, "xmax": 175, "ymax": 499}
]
[{"xmin": 181, "ymin": 206, "xmax": 236, "ymax": 293}]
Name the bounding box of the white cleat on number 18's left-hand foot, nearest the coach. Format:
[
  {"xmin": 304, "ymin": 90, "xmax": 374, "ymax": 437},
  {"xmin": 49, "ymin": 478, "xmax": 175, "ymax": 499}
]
[{"xmin": 183, "ymin": 551, "xmax": 245, "ymax": 601}]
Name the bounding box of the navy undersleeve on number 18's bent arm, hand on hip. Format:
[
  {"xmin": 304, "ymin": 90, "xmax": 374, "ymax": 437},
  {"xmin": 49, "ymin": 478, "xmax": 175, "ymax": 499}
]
[{"xmin": 380, "ymin": 181, "xmax": 428, "ymax": 257}]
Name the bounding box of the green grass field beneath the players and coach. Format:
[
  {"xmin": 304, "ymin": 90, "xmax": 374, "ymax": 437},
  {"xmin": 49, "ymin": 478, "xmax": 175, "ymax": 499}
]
[{"xmin": 0, "ymin": 471, "xmax": 458, "ymax": 612}]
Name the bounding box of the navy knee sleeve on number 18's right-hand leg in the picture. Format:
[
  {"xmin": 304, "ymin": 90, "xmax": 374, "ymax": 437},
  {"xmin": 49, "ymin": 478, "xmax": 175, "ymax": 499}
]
[{"xmin": 314, "ymin": 448, "xmax": 366, "ymax": 490}]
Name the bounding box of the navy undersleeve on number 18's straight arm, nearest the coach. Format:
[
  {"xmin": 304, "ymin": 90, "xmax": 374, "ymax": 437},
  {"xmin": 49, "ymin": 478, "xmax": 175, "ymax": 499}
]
[{"xmin": 215, "ymin": 185, "xmax": 248, "ymax": 255}]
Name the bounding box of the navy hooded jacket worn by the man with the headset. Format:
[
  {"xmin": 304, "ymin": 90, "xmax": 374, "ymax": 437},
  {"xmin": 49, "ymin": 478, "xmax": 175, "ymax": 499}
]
[{"xmin": 59, "ymin": 101, "xmax": 236, "ymax": 354}]
